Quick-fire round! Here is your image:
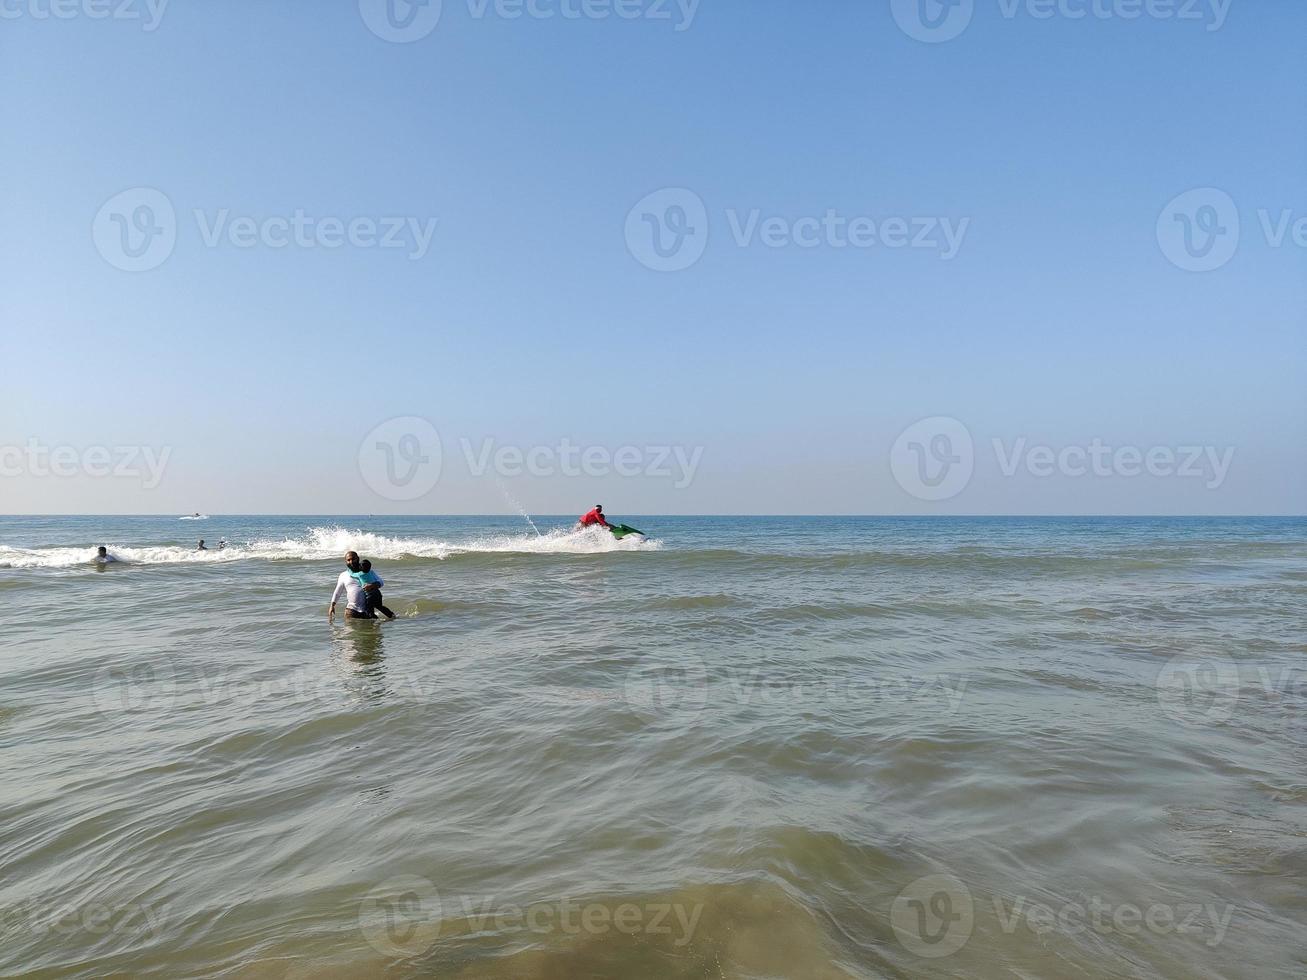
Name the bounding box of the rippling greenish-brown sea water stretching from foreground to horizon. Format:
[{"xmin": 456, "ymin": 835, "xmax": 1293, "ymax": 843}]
[{"xmin": 0, "ymin": 516, "xmax": 1307, "ymax": 977}]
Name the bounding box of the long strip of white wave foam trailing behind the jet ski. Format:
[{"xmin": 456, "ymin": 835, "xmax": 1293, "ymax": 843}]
[{"xmin": 0, "ymin": 527, "xmax": 663, "ymax": 568}]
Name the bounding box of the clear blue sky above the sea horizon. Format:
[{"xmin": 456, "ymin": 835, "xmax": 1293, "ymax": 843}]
[{"xmin": 0, "ymin": 0, "xmax": 1307, "ymax": 514}]
